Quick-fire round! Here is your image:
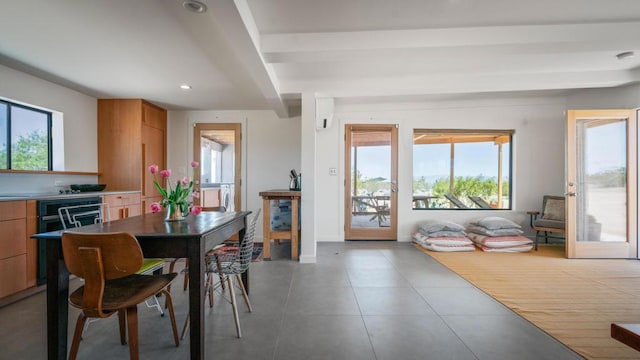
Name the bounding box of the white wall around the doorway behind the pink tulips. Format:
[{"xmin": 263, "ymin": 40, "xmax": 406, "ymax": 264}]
[{"xmin": 167, "ymin": 111, "xmax": 300, "ymax": 239}]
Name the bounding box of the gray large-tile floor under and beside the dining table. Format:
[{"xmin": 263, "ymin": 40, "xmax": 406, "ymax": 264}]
[{"xmin": 0, "ymin": 242, "xmax": 581, "ymax": 360}]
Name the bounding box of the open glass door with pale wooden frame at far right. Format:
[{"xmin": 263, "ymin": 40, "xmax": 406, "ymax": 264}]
[{"xmin": 567, "ymin": 110, "xmax": 638, "ymax": 258}]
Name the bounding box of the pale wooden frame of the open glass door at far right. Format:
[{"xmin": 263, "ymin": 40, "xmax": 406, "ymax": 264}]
[{"xmin": 565, "ymin": 109, "xmax": 638, "ymax": 259}]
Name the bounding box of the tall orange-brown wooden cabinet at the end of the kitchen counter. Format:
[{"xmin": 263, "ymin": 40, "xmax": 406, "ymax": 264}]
[{"xmin": 98, "ymin": 99, "xmax": 167, "ymax": 202}]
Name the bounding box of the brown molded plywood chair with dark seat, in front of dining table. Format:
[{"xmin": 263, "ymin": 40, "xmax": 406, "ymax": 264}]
[{"xmin": 62, "ymin": 232, "xmax": 180, "ymax": 360}]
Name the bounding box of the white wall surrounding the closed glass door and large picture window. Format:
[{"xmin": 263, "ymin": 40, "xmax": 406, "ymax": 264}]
[{"xmin": 316, "ymin": 98, "xmax": 566, "ymax": 241}]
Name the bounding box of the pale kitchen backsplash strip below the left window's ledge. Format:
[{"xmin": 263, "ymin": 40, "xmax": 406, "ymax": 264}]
[{"xmin": 0, "ymin": 173, "xmax": 99, "ymax": 195}]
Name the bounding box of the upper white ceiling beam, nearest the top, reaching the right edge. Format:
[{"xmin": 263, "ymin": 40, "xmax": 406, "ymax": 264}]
[{"xmin": 260, "ymin": 22, "xmax": 640, "ymax": 54}]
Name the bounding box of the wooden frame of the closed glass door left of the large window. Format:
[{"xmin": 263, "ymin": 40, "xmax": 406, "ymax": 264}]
[{"xmin": 344, "ymin": 124, "xmax": 398, "ymax": 241}]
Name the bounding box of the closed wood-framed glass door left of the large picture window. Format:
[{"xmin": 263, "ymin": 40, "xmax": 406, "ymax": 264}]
[{"xmin": 345, "ymin": 125, "xmax": 398, "ymax": 240}]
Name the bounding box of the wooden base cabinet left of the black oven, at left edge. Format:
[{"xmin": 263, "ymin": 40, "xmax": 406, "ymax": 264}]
[{"xmin": 0, "ymin": 201, "xmax": 27, "ymax": 298}]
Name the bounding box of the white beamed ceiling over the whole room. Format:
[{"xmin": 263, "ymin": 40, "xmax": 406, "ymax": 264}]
[{"xmin": 0, "ymin": 0, "xmax": 640, "ymax": 116}]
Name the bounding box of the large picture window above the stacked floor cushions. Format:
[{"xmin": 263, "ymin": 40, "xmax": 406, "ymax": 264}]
[{"xmin": 413, "ymin": 129, "xmax": 513, "ymax": 210}]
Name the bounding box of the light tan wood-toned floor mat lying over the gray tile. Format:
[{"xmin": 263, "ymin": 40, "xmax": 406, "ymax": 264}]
[{"xmin": 418, "ymin": 246, "xmax": 640, "ymax": 359}]
